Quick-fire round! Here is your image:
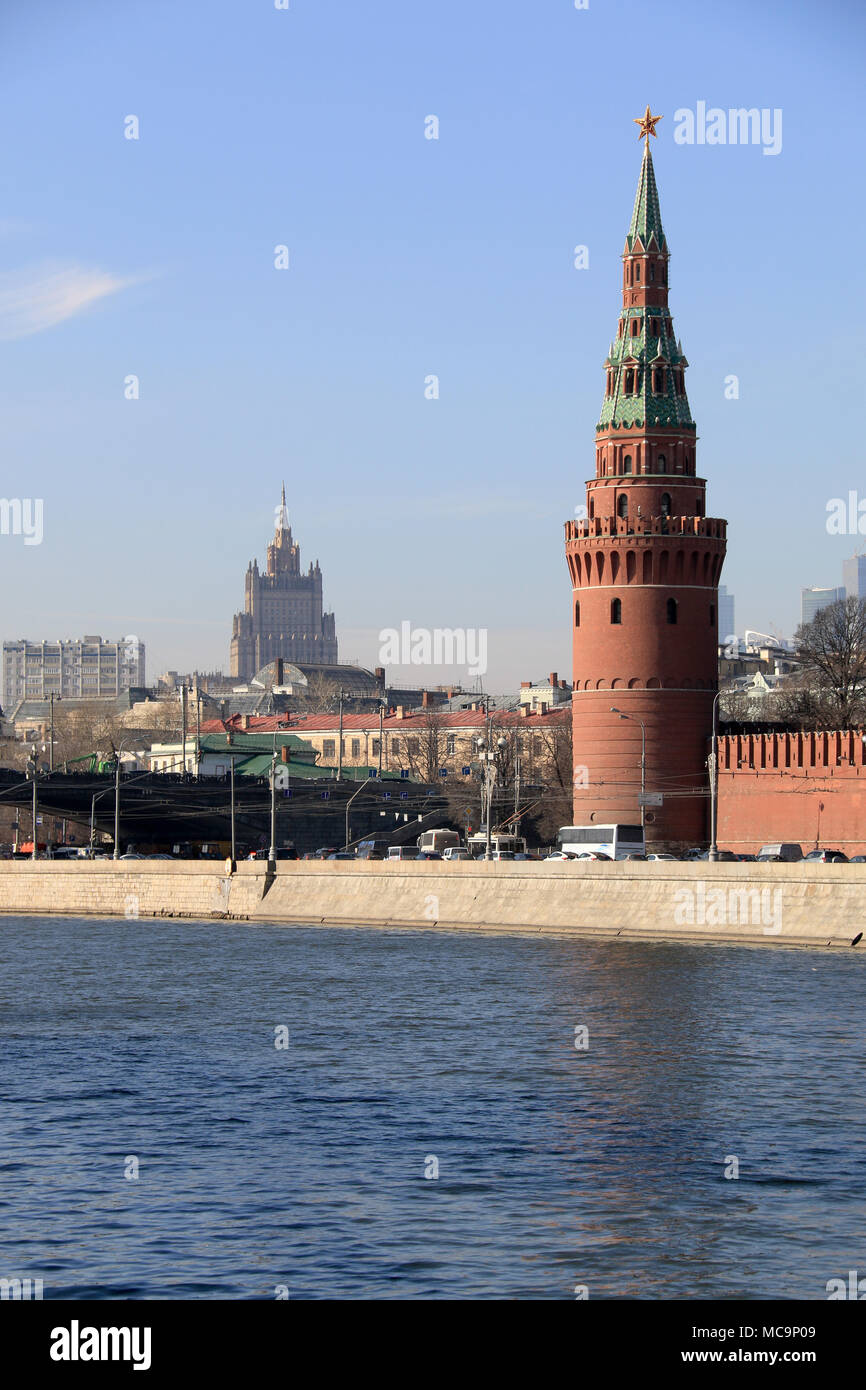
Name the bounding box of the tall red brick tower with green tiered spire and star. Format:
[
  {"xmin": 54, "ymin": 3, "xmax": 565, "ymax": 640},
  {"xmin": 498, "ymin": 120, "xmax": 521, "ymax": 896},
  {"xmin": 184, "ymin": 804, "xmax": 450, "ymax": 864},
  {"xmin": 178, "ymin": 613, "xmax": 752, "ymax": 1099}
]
[{"xmin": 566, "ymin": 107, "xmax": 726, "ymax": 847}]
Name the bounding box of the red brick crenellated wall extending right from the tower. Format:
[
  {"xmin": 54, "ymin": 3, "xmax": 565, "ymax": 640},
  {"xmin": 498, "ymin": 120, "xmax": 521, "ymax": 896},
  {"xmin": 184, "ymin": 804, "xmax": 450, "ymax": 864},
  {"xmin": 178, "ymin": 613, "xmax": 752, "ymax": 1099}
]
[{"xmin": 717, "ymin": 730, "xmax": 866, "ymax": 858}]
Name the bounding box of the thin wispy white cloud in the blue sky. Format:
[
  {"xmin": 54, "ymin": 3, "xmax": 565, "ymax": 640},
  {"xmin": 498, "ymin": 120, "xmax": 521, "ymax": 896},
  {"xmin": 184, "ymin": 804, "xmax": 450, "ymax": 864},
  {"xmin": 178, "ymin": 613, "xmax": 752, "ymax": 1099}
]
[{"xmin": 0, "ymin": 264, "xmax": 140, "ymax": 342}]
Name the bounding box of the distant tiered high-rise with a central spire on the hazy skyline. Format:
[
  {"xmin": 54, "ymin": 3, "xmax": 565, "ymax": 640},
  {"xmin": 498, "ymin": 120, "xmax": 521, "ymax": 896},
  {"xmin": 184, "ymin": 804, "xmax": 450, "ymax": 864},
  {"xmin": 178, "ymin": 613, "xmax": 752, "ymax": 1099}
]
[{"xmin": 231, "ymin": 487, "xmax": 338, "ymax": 681}]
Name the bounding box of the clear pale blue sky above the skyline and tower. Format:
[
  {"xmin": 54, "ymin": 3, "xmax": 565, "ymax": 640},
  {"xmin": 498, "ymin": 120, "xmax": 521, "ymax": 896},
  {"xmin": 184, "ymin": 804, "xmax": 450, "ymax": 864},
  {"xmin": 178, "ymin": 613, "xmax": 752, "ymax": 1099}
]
[{"xmin": 0, "ymin": 0, "xmax": 866, "ymax": 691}]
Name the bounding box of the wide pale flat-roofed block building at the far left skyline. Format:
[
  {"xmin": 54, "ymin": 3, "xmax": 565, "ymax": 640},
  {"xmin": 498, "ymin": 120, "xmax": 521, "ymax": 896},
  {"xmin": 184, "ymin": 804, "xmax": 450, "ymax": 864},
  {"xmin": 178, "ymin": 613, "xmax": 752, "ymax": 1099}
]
[{"xmin": 3, "ymin": 637, "xmax": 145, "ymax": 717}]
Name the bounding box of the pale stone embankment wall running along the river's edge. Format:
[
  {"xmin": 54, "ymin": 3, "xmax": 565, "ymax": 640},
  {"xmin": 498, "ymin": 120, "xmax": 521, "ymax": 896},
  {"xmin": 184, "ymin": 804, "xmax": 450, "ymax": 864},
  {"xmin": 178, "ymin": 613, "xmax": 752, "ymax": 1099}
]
[{"xmin": 0, "ymin": 860, "xmax": 866, "ymax": 951}]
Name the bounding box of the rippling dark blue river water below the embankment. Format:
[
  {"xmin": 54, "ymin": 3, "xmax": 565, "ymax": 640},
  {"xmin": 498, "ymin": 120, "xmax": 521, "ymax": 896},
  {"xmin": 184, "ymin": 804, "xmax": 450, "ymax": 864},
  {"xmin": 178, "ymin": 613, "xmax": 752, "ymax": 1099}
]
[{"xmin": 0, "ymin": 917, "xmax": 866, "ymax": 1298}]
